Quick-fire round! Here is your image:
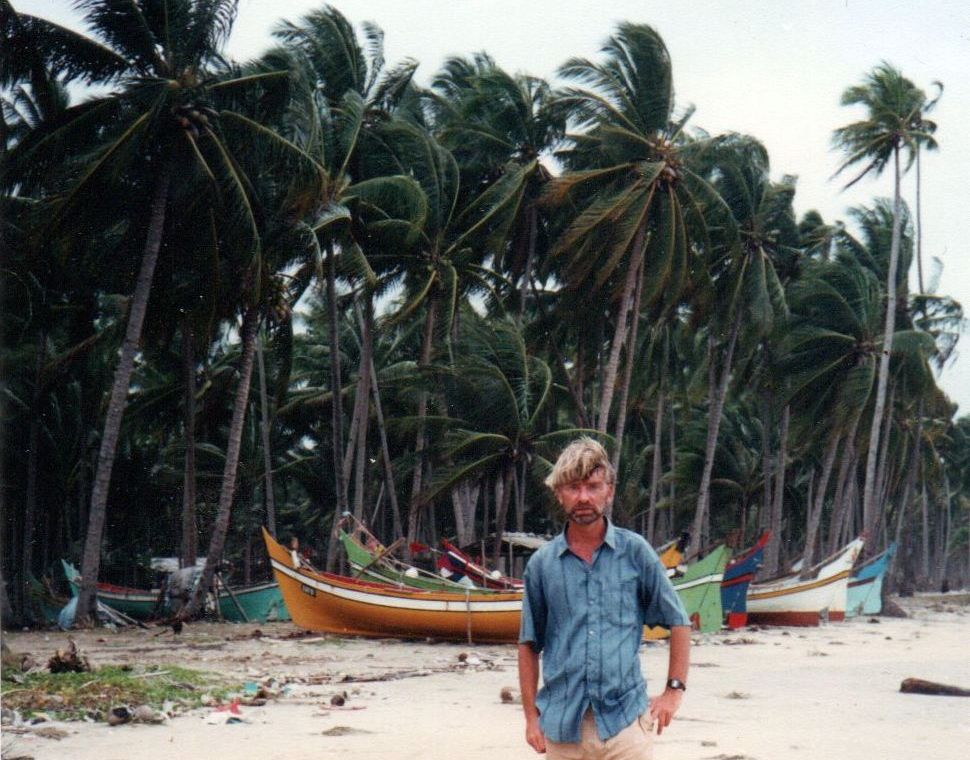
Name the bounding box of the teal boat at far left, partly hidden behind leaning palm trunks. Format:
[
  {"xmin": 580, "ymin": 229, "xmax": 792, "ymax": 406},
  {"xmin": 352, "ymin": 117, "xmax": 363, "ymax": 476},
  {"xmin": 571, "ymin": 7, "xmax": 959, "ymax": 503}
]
[{"xmin": 61, "ymin": 560, "xmax": 290, "ymax": 623}]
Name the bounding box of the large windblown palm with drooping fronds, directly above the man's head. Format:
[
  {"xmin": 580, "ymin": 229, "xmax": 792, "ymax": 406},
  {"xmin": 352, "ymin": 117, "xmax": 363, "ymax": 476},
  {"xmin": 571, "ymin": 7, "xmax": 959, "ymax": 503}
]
[{"xmin": 547, "ymin": 23, "xmax": 712, "ymax": 445}]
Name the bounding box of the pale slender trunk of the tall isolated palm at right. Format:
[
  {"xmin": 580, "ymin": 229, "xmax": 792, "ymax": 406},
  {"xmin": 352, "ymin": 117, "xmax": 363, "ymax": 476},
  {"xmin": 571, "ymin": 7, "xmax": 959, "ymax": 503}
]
[{"xmin": 862, "ymin": 145, "xmax": 902, "ymax": 556}]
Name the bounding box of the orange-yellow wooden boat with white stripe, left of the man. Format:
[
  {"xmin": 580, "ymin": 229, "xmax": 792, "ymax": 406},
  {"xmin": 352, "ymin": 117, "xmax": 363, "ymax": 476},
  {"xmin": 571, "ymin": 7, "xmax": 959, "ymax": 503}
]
[{"xmin": 263, "ymin": 529, "xmax": 522, "ymax": 643}]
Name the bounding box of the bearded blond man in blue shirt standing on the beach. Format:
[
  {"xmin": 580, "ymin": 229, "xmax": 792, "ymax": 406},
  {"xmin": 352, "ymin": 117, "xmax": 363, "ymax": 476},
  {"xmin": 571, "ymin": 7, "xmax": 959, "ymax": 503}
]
[{"xmin": 519, "ymin": 438, "xmax": 690, "ymax": 760}]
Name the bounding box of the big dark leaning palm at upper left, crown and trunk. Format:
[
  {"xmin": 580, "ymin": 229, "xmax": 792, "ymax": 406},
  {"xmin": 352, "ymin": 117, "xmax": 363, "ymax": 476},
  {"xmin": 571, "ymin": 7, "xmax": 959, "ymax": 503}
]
[{"xmin": 6, "ymin": 0, "xmax": 322, "ymax": 622}]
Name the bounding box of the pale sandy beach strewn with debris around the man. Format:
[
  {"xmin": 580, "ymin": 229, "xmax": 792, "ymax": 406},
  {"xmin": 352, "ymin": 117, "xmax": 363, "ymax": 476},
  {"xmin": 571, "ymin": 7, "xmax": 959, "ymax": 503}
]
[{"xmin": 3, "ymin": 594, "xmax": 970, "ymax": 760}]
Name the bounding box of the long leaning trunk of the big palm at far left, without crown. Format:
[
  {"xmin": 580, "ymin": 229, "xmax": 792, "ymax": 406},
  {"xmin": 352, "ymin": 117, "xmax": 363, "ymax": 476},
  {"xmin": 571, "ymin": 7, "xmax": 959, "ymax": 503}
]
[{"xmin": 75, "ymin": 167, "xmax": 171, "ymax": 626}]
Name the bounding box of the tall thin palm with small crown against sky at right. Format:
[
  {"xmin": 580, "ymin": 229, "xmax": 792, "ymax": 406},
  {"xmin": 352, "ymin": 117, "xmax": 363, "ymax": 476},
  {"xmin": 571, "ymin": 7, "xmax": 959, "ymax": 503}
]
[{"xmin": 833, "ymin": 63, "xmax": 931, "ymax": 553}]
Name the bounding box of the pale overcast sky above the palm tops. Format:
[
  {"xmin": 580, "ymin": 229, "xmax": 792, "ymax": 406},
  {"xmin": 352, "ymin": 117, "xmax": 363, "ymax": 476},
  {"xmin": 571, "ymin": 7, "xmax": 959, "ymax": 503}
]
[{"xmin": 20, "ymin": 0, "xmax": 970, "ymax": 414}]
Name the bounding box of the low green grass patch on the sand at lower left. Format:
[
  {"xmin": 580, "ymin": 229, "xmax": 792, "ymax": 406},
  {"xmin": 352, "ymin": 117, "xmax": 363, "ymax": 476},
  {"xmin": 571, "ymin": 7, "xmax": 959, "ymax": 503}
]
[{"xmin": 0, "ymin": 665, "xmax": 239, "ymax": 720}]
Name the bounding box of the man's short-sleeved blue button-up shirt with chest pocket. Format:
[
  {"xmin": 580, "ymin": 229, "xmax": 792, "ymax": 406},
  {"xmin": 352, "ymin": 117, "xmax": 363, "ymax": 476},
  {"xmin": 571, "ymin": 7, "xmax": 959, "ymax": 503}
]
[{"xmin": 519, "ymin": 523, "xmax": 690, "ymax": 742}]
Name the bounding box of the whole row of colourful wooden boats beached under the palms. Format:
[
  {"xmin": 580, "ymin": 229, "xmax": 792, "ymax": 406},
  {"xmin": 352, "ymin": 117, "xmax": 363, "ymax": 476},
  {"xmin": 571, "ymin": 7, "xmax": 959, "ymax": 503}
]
[{"xmin": 45, "ymin": 525, "xmax": 895, "ymax": 642}]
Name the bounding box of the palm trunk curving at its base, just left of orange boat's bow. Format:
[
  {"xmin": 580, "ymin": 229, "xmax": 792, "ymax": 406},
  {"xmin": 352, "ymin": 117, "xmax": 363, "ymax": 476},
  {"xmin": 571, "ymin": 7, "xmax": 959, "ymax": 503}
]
[{"xmin": 179, "ymin": 306, "xmax": 259, "ymax": 620}]
